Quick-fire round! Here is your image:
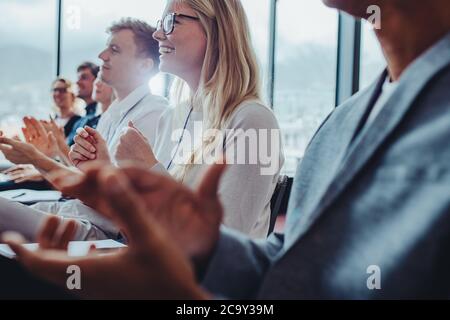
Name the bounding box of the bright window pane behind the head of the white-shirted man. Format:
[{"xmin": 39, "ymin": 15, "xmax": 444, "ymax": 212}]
[{"xmin": 61, "ymin": 0, "xmax": 166, "ymax": 95}]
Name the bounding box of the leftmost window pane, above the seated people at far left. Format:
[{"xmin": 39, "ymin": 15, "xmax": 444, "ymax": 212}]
[{"xmin": 0, "ymin": 0, "xmax": 56, "ymax": 137}]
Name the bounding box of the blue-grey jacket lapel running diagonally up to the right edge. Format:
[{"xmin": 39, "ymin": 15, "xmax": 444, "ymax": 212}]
[{"xmin": 286, "ymin": 35, "xmax": 450, "ymax": 246}]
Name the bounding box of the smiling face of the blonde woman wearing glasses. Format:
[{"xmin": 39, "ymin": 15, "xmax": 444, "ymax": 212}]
[{"xmin": 153, "ymin": 1, "xmax": 207, "ymax": 83}]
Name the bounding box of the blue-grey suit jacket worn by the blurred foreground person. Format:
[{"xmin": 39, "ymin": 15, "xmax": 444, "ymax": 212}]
[{"xmin": 203, "ymin": 34, "xmax": 450, "ymax": 299}]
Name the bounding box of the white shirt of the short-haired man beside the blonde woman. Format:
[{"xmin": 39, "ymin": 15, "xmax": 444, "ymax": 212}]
[{"xmin": 97, "ymin": 84, "xmax": 168, "ymax": 156}]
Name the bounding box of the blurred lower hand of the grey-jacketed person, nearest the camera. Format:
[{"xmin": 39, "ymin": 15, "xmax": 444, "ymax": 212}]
[{"xmin": 4, "ymin": 169, "xmax": 209, "ymax": 300}]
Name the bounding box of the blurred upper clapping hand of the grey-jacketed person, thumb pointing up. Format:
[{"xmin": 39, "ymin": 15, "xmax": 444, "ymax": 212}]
[{"xmin": 60, "ymin": 161, "xmax": 225, "ymax": 261}]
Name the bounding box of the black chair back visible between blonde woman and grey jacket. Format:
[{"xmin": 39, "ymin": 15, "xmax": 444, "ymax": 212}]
[{"xmin": 268, "ymin": 176, "xmax": 294, "ymax": 235}]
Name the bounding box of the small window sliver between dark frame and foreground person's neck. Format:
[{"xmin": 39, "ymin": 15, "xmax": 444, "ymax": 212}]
[{"xmin": 360, "ymin": 22, "xmax": 386, "ymax": 89}]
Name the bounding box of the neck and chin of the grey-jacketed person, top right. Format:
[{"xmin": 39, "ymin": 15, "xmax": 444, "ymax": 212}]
[{"xmin": 376, "ymin": 0, "xmax": 450, "ymax": 81}]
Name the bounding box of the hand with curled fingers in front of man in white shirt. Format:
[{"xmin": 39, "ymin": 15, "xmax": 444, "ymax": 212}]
[{"xmin": 69, "ymin": 127, "xmax": 111, "ymax": 171}]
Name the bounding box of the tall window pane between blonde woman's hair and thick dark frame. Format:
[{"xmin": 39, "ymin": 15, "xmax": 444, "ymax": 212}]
[{"xmin": 274, "ymin": 0, "xmax": 338, "ymax": 174}]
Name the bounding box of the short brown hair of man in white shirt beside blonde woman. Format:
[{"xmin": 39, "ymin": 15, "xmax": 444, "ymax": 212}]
[{"xmin": 107, "ymin": 18, "xmax": 159, "ymax": 67}]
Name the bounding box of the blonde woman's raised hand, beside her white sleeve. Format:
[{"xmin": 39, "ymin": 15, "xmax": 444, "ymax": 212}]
[{"xmin": 115, "ymin": 122, "xmax": 158, "ymax": 168}]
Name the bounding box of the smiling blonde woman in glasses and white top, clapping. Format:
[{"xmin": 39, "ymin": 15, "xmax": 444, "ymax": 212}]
[{"xmin": 73, "ymin": 0, "xmax": 284, "ymax": 238}]
